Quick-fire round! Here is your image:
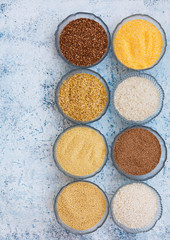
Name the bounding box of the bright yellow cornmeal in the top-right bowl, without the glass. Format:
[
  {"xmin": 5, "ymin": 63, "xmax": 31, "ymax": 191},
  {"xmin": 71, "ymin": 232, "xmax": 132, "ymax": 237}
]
[{"xmin": 113, "ymin": 19, "xmax": 163, "ymax": 69}]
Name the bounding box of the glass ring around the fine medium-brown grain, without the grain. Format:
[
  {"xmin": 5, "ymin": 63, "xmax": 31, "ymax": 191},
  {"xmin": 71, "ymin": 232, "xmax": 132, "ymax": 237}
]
[{"xmin": 111, "ymin": 126, "xmax": 167, "ymax": 181}]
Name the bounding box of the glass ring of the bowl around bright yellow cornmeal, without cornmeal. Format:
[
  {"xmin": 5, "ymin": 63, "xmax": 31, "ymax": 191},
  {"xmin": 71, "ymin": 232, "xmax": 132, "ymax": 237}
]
[{"xmin": 112, "ymin": 14, "xmax": 167, "ymax": 71}]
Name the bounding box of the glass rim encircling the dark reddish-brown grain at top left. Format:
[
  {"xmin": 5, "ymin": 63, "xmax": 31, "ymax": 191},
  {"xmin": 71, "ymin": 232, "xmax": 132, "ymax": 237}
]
[{"xmin": 54, "ymin": 12, "xmax": 111, "ymax": 69}]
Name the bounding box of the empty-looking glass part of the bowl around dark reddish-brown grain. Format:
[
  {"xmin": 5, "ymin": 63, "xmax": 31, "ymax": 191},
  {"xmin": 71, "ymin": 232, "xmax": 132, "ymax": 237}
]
[{"xmin": 55, "ymin": 12, "xmax": 110, "ymax": 68}]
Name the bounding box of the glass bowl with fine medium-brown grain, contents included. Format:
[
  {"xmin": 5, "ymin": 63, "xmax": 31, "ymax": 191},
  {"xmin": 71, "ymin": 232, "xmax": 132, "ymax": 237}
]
[{"xmin": 111, "ymin": 126, "xmax": 167, "ymax": 181}]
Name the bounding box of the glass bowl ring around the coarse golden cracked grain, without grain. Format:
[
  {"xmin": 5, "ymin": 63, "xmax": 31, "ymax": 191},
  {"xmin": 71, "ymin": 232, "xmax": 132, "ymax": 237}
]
[{"xmin": 55, "ymin": 69, "xmax": 110, "ymax": 124}]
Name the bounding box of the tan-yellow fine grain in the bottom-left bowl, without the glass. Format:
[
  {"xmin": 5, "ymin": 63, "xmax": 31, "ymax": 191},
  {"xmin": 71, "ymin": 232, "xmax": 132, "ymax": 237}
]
[{"xmin": 56, "ymin": 182, "xmax": 106, "ymax": 230}]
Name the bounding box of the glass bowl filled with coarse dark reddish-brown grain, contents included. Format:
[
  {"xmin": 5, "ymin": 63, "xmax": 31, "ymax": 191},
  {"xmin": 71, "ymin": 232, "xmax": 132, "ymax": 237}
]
[{"xmin": 55, "ymin": 12, "xmax": 110, "ymax": 68}]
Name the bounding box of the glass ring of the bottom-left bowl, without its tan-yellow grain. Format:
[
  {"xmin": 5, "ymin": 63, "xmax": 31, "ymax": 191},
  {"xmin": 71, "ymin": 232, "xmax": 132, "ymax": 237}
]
[{"xmin": 54, "ymin": 181, "xmax": 109, "ymax": 235}]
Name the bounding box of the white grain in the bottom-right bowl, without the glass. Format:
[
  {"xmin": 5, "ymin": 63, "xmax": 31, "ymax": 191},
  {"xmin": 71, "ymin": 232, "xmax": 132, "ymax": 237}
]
[{"xmin": 112, "ymin": 183, "xmax": 158, "ymax": 229}]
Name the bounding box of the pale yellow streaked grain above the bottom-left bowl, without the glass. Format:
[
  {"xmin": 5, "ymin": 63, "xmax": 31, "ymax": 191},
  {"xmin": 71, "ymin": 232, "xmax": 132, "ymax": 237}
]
[{"xmin": 56, "ymin": 127, "xmax": 106, "ymax": 176}]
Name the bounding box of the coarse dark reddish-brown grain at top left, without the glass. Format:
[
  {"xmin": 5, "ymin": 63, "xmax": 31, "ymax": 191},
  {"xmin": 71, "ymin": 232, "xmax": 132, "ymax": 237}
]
[{"xmin": 60, "ymin": 18, "xmax": 108, "ymax": 66}]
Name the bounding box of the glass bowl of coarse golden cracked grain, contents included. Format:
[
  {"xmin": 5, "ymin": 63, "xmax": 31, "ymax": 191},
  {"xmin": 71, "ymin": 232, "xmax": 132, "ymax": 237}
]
[{"xmin": 55, "ymin": 69, "xmax": 110, "ymax": 124}]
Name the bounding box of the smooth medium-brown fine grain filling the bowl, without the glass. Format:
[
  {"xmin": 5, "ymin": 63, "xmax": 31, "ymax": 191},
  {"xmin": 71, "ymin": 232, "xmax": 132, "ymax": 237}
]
[{"xmin": 113, "ymin": 127, "xmax": 161, "ymax": 175}]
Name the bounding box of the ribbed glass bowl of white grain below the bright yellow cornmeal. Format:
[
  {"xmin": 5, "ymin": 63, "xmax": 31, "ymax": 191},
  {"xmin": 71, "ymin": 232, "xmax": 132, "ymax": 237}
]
[{"xmin": 113, "ymin": 73, "xmax": 164, "ymax": 125}]
